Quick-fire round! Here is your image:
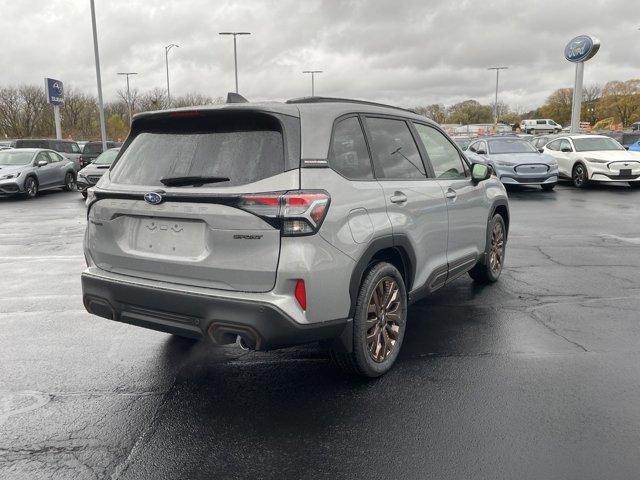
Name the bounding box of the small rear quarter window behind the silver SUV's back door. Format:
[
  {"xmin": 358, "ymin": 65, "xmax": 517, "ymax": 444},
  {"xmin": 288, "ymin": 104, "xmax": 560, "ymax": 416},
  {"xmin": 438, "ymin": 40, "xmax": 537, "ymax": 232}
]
[{"xmin": 329, "ymin": 117, "xmax": 373, "ymax": 180}]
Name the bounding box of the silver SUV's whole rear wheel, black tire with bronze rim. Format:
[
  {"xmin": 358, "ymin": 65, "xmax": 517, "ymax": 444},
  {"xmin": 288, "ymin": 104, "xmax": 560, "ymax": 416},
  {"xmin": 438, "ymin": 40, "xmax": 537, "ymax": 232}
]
[{"xmin": 330, "ymin": 262, "xmax": 407, "ymax": 378}]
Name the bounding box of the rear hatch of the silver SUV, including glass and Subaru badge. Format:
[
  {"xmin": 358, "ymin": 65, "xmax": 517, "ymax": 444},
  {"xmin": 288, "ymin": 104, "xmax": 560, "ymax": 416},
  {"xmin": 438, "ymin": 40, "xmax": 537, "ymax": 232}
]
[{"xmin": 87, "ymin": 108, "xmax": 300, "ymax": 292}]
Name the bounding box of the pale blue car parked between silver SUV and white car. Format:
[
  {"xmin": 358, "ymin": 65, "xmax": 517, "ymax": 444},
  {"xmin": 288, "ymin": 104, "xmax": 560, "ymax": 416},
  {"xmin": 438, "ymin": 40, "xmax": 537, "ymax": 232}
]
[{"xmin": 469, "ymin": 137, "xmax": 558, "ymax": 190}]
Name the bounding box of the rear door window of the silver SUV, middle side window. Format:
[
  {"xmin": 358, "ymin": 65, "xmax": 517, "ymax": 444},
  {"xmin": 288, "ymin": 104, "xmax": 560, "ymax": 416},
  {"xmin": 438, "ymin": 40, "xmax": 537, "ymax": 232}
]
[{"xmin": 367, "ymin": 117, "xmax": 426, "ymax": 180}]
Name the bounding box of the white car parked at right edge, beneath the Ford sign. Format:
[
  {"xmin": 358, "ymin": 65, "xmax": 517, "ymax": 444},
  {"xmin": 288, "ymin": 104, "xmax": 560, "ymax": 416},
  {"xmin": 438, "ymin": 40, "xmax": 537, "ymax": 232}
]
[{"xmin": 544, "ymin": 135, "xmax": 640, "ymax": 188}]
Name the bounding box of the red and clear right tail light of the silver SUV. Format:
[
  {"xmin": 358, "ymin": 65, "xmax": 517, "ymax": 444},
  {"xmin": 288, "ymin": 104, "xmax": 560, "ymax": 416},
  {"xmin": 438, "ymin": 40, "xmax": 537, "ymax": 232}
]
[{"xmin": 237, "ymin": 190, "xmax": 331, "ymax": 236}]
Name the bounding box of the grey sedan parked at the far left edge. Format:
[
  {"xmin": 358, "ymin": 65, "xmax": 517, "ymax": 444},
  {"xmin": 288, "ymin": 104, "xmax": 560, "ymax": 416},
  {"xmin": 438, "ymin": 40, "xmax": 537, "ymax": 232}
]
[{"xmin": 0, "ymin": 148, "xmax": 76, "ymax": 198}]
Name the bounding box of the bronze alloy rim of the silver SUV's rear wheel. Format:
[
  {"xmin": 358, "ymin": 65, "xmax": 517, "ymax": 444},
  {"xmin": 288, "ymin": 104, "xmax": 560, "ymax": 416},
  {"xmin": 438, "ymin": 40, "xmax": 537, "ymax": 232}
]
[{"xmin": 367, "ymin": 277, "xmax": 402, "ymax": 363}]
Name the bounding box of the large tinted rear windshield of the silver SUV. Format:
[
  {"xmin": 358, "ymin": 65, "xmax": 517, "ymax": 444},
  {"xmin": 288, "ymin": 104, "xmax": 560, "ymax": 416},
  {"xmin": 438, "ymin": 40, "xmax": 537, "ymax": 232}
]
[{"xmin": 111, "ymin": 112, "xmax": 292, "ymax": 187}]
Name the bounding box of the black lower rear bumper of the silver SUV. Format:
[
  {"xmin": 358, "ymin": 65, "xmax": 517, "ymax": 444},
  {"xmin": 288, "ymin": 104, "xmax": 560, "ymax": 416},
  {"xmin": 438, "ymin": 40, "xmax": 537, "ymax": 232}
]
[{"xmin": 82, "ymin": 272, "xmax": 351, "ymax": 350}]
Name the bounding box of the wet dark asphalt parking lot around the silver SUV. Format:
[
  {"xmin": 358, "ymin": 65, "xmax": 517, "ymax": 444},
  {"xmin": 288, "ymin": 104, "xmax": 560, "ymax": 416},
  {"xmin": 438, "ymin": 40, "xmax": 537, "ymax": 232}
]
[{"xmin": 0, "ymin": 182, "xmax": 640, "ymax": 480}]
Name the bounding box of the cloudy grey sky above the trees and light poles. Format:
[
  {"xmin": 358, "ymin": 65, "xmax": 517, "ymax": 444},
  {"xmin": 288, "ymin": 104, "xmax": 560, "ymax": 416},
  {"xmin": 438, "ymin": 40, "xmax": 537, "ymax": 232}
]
[{"xmin": 0, "ymin": 0, "xmax": 640, "ymax": 109}]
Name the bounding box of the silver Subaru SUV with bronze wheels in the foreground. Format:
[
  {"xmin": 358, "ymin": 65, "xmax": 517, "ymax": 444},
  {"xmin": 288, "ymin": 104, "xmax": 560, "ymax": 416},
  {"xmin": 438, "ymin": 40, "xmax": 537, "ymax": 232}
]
[{"xmin": 82, "ymin": 97, "xmax": 509, "ymax": 377}]
